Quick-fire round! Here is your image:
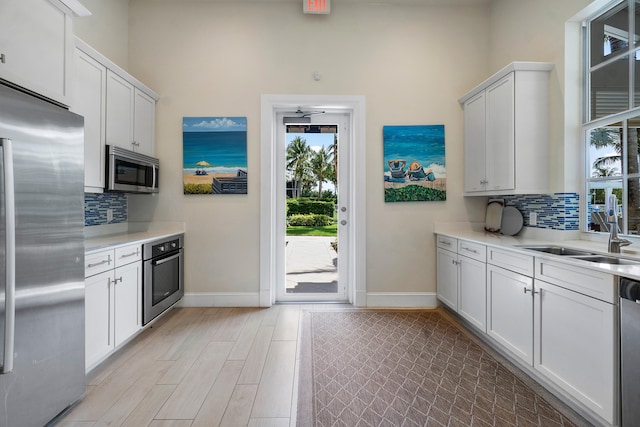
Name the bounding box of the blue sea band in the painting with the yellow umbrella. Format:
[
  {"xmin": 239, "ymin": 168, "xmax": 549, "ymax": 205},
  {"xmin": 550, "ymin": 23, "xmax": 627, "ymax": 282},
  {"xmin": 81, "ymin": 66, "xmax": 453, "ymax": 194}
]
[{"xmin": 182, "ymin": 131, "xmax": 247, "ymax": 173}]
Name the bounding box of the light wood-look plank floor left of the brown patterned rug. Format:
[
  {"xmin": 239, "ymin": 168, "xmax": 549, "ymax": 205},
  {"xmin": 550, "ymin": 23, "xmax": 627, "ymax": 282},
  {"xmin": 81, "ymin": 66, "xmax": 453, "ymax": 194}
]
[{"xmin": 56, "ymin": 304, "xmax": 336, "ymax": 427}]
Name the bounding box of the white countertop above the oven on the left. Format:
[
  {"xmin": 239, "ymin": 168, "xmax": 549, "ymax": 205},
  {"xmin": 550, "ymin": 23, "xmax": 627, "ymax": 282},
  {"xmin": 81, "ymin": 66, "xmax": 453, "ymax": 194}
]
[{"xmin": 84, "ymin": 222, "xmax": 185, "ymax": 254}]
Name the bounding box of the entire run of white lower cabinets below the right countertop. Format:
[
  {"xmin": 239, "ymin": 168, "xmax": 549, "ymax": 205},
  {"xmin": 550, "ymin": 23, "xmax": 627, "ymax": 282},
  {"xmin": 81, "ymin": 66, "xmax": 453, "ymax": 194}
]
[{"xmin": 437, "ymin": 236, "xmax": 619, "ymax": 425}]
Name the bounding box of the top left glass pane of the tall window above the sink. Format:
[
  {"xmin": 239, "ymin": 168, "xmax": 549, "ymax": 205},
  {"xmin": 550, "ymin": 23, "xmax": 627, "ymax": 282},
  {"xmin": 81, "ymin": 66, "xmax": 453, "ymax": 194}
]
[{"xmin": 590, "ymin": 2, "xmax": 629, "ymax": 66}]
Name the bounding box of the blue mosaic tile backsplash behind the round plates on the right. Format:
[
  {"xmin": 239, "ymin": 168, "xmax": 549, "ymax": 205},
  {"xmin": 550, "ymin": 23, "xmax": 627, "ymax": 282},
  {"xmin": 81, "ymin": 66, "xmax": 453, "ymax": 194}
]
[{"xmin": 496, "ymin": 193, "xmax": 580, "ymax": 230}]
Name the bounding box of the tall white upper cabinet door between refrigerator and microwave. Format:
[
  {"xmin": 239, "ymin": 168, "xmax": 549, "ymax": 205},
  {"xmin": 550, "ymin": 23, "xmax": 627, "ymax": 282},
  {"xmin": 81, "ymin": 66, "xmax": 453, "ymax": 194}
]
[{"xmin": 71, "ymin": 50, "xmax": 107, "ymax": 192}]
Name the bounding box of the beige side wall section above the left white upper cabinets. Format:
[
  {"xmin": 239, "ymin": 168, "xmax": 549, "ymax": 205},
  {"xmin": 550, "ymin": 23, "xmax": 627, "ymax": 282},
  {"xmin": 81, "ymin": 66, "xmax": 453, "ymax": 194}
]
[{"xmin": 73, "ymin": 0, "xmax": 129, "ymax": 70}]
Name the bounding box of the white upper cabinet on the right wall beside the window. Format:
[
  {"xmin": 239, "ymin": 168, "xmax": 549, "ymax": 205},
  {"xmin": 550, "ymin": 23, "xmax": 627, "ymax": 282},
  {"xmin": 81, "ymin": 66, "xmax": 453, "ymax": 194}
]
[{"xmin": 460, "ymin": 62, "xmax": 553, "ymax": 196}]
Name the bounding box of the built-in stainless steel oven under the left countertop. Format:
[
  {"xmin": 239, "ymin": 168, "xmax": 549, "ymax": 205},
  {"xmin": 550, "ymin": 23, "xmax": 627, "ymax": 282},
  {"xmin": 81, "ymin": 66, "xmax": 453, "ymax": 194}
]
[{"xmin": 142, "ymin": 234, "xmax": 184, "ymax": 325}]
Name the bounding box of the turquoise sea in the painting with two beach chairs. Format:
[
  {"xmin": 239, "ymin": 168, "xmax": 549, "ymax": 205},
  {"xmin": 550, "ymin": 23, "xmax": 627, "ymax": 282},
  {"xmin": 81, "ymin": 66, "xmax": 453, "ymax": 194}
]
[{"xmin": 382, "ymin": 125, "xmax": 446, "ymax": 178}]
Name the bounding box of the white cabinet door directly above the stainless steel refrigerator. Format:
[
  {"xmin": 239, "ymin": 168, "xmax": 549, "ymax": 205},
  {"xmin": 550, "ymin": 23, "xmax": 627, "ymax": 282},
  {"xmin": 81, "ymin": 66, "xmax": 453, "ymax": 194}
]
[{"xmin": 0, "ymin": 0, "xmax": 73, "ymax": 105}]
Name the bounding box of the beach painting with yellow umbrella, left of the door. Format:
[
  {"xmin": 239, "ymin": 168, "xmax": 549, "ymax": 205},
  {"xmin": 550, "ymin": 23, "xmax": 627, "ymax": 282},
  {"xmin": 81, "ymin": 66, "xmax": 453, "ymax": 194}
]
[{"xmin": 182, "ymin": 117, "xmax": 248, "ymax": 194}]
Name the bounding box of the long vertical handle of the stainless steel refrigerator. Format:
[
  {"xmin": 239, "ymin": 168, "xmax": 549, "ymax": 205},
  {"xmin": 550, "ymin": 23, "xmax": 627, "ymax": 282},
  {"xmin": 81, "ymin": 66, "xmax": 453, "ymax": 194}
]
[{"xmin": 0, "ymin": 138, "xmax": 16, "ymax": 374}]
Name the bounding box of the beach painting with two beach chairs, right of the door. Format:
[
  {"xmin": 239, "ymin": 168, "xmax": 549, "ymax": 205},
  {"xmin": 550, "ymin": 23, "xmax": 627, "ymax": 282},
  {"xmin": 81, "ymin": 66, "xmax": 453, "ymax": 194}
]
[{"xmin": 382, "ymin": 125, "xmax": 447, "ymax": 202}]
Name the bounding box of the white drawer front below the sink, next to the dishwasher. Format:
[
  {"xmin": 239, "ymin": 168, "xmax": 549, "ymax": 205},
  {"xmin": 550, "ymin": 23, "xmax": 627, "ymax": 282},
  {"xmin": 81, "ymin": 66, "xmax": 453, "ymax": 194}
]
[{"xmin": 535, "ymin": 258, "xmax": 617, "ymax": 304}]
